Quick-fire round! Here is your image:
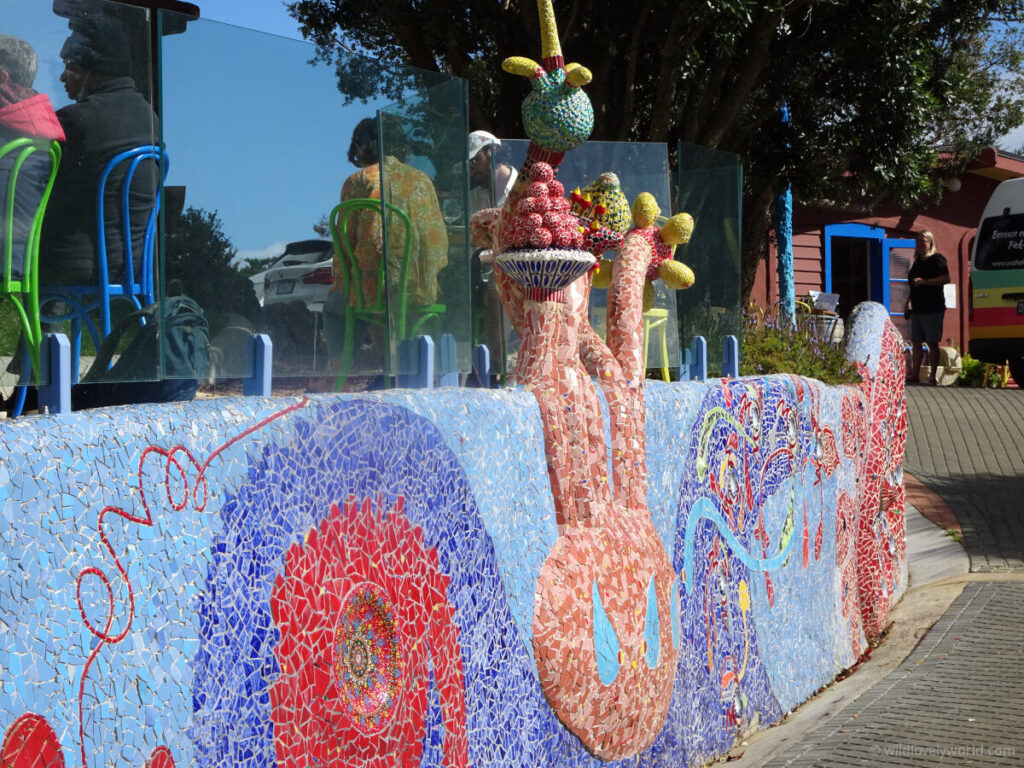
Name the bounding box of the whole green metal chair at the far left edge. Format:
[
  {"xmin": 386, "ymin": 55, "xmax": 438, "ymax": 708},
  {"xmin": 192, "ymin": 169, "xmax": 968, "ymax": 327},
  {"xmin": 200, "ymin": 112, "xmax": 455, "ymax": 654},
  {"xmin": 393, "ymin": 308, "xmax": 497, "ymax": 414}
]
[{"xmin": 0, "ymin": 138, "xmax": 60, "ymax": 393}]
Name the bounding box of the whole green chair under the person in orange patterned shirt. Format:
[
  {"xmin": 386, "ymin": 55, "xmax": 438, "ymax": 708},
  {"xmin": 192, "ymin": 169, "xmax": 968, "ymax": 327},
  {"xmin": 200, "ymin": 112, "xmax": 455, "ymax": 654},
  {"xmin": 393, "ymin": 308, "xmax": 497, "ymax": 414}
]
[{"xmin": 328, "ymin": 198, "xmax": 446, "ymax": 389}]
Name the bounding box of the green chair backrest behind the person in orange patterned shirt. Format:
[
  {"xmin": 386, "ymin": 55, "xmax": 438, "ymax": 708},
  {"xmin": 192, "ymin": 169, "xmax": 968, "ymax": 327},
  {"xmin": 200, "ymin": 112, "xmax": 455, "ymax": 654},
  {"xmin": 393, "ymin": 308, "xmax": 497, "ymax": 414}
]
[{"xmin": 328, "ymin": 198, "xmax": 413, "ymax": 339}]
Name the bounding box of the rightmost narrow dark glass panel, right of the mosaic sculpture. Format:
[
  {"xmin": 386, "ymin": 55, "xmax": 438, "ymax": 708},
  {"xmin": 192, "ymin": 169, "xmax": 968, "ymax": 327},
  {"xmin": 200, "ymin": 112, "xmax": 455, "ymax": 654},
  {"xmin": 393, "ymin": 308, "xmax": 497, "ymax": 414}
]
[{"xmin": 676, "ymin": 142, "xmax": 743, "ymax": 376}]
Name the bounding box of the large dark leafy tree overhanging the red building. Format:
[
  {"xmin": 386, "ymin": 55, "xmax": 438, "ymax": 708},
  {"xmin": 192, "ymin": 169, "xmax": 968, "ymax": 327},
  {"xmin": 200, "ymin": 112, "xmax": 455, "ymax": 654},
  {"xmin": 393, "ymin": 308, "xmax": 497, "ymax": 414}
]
[{"xmin": 288, "ymin": 0, "xmax": 1024, "ymax": 296}]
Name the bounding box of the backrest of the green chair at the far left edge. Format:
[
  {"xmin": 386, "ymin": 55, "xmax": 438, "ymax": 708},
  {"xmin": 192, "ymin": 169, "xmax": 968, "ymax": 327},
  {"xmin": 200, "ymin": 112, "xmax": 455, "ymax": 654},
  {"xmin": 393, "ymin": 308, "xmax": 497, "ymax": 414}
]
[{"xmin": 0, "ymin": 138, "xmax": 60, "ymax": 294}]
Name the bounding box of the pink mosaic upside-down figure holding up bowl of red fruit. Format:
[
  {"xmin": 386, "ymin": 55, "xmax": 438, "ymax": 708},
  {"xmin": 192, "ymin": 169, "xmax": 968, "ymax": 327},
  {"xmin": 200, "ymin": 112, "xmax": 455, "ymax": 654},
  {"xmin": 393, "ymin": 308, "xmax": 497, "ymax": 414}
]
[{"xmin": 487, "ymin": 0, "xmax": 692, "ymax": 760}]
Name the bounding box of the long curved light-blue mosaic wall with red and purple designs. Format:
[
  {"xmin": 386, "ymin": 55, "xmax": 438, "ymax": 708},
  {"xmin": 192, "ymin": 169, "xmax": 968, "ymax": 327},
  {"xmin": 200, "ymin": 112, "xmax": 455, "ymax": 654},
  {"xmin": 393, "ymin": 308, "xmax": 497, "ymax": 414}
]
[{"xmin": 0, "ymin": 305, "xmax": 906, "ymax": 768}]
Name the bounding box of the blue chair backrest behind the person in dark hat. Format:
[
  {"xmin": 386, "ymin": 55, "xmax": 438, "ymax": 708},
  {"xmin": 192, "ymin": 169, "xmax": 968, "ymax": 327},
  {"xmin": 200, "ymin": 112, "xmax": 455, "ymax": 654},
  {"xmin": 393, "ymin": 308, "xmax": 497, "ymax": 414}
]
[{"xmin": 96, "ymin": 144, "xmax": 170, "ymax": 304}]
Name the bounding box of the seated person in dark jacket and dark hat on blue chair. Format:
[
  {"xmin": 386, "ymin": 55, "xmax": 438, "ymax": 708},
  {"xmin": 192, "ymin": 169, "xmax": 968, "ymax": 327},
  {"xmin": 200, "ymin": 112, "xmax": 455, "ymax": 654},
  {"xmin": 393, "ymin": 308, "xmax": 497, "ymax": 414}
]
[{"xmin": 39, "ymin": 15, "xmax": 158, "ymax": 285}]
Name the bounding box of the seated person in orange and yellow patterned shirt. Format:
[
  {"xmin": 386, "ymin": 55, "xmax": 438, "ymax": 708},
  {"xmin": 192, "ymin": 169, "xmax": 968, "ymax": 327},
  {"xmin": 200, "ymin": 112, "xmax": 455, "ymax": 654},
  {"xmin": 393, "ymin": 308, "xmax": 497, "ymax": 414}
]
[{"xmin": 324, "ymin": 118, "xmax": 447, "ymax": 370}]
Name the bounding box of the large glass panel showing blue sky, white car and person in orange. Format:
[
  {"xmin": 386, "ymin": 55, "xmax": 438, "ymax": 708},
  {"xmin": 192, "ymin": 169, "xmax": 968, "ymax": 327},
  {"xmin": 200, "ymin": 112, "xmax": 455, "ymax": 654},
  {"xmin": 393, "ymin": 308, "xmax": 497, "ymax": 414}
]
[{"xmin": 161, "ymin": 12, "xmax": 470, "ymax": 389}]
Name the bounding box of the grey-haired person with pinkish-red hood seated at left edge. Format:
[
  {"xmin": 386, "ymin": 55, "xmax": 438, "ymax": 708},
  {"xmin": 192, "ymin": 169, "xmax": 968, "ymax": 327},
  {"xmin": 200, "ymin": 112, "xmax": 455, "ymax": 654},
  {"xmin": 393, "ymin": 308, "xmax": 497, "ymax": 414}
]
[{"xmin": 0, "ymin": 35, "xmax": 65, "ymax": 280}]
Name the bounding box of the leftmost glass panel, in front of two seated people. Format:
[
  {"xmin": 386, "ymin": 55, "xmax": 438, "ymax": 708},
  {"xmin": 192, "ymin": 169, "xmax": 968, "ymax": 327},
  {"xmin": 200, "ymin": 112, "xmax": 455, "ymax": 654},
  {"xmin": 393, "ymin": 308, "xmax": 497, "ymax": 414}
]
[{"xmin": 0, "ymin": 0, "xmax": 160, "ymax": 397}]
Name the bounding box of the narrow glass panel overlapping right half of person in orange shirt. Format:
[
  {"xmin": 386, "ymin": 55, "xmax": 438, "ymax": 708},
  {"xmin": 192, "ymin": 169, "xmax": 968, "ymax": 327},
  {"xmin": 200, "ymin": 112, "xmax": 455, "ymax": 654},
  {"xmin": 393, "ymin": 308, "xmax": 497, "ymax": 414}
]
[{"xmin": 370, "ymin": 75, "xmax": 472, "ymax": 382}]
